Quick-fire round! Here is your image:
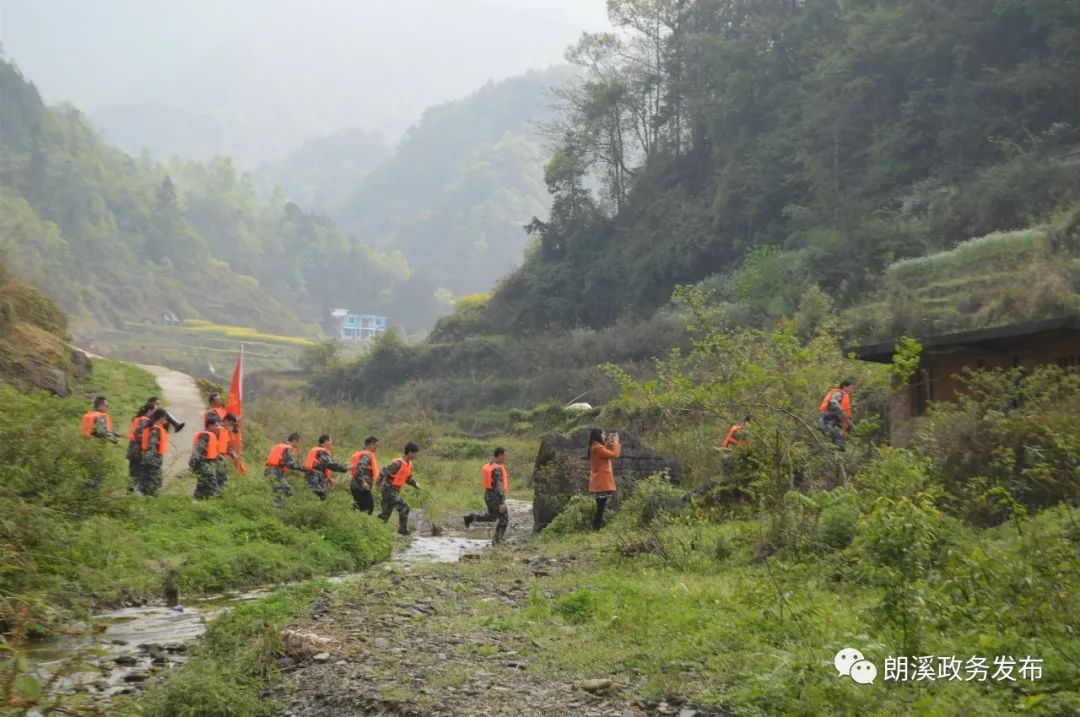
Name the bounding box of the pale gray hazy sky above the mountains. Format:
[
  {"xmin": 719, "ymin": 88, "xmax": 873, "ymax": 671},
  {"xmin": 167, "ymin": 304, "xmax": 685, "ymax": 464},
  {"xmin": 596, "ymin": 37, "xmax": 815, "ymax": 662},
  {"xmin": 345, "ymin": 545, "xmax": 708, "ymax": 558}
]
[{"xmin": 0, "ymin": 0, "xmax": 608, "ymax": 165}]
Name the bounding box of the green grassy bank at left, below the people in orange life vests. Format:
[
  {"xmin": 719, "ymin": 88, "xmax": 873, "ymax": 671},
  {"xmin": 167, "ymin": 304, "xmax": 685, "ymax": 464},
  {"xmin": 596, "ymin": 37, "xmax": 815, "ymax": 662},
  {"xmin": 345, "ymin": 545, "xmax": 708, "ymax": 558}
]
[{"xmin": 0, "ymin": 361, "xmax": 390, "ymax": 625}]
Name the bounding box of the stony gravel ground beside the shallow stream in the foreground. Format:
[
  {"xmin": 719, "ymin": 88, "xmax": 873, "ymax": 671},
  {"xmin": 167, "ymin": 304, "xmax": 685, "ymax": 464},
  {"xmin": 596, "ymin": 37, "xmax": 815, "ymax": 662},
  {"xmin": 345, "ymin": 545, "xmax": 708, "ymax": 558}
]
[{"xmin": 272, "ymin": 501, "xmax": 716, "ymax": 717}]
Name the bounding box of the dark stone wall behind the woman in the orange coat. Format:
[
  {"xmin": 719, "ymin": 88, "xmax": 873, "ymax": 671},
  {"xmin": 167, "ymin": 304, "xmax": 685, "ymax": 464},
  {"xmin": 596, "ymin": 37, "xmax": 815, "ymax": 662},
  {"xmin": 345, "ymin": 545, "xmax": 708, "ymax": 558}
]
[{"xmin": 532, "ymin": 429, "xmax": 683, "ymax": 532}]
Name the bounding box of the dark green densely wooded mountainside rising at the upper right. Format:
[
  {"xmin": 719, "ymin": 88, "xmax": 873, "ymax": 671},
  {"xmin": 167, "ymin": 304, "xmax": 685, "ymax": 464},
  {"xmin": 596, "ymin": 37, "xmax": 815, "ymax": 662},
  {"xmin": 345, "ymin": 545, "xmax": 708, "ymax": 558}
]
[{"xmin": 440, "ymin": 0, "xmax": 1080, "ymax": 333}]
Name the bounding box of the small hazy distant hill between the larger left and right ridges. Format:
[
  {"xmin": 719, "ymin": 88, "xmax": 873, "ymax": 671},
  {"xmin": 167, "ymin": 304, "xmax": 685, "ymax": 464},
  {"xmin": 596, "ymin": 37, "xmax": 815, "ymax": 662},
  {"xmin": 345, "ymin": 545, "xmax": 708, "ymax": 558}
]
[{"xmin": 253, "ymin": 128, "xmax": 390, "ymax": 214}]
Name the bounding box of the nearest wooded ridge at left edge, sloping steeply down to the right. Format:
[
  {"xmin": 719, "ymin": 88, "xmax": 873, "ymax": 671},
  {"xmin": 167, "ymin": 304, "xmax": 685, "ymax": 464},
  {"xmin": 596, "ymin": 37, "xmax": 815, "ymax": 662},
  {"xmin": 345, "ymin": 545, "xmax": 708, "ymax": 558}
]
[{"xmin": 0, "ymin": 60, "xmax": 313, "ymax": 333}]
